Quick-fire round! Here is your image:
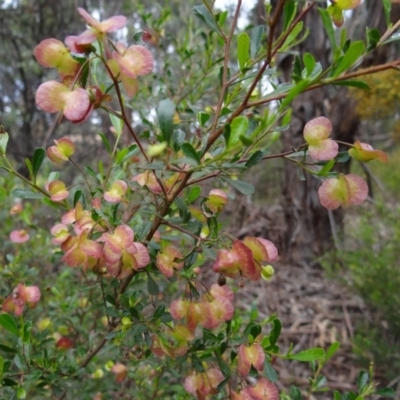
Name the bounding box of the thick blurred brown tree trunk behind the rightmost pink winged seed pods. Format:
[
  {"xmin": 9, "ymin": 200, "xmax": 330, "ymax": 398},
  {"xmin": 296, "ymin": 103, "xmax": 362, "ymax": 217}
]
[{"xmin": 281, "ymin": 1, "xmax": 400, "ymax": 261}]
